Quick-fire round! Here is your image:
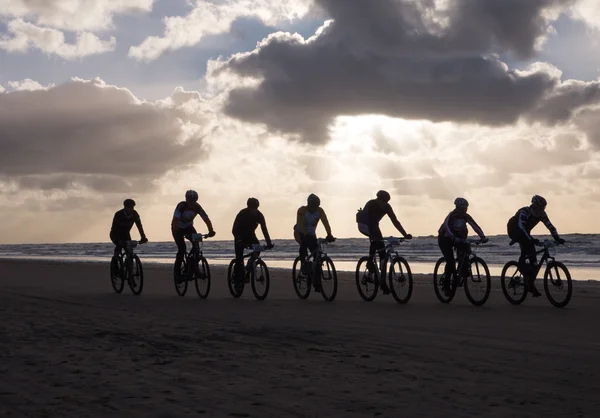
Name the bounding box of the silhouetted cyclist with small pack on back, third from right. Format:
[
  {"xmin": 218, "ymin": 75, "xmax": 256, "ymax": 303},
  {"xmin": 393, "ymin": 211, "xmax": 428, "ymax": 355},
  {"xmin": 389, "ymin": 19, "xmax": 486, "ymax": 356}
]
[{"xmin": 356, "ymin": 190, "xmax": 412, "ymax": 294}]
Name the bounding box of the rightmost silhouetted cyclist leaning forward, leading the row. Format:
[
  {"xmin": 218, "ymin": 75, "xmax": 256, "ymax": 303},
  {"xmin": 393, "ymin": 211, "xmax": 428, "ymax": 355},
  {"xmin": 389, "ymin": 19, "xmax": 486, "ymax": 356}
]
[{"xmin": 506, "ymin": 195, "xmax": 565, "ymax": 297}]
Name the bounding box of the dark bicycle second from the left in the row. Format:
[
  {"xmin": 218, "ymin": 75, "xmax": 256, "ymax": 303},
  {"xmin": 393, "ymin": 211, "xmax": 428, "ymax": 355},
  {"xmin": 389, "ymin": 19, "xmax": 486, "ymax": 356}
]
[{"xmin": 173, "ymin": 234, "xmax": 210, "ymax": 299}]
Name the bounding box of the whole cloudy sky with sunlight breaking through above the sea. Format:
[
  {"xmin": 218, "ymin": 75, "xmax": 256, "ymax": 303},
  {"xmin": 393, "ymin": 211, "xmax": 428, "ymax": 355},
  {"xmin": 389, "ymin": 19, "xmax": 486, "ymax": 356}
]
[{"xmin": 0, "ymin": 0, "xmax": 600, "ymax": 243}]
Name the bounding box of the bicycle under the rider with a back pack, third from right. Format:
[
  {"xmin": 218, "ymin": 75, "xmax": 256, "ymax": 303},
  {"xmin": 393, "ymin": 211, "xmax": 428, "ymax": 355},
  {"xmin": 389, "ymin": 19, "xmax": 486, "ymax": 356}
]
[{"xmin": 356, "ymin": 237, "xmax": 413, "ymax": 303}]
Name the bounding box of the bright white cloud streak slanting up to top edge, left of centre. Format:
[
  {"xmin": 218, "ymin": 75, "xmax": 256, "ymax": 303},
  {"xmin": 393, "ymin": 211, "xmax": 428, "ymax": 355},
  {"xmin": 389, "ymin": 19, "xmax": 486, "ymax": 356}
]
[{"xmin": 129, "ymin": 0, "xmax": 312, "ymax": 61}]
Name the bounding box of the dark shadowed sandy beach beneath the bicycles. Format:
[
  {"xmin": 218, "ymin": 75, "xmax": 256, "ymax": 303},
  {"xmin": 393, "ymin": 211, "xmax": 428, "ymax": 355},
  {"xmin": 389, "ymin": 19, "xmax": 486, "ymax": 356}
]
[{"xmin": 0, "ymin": 259, "xmax": 600, "ymax": 418}]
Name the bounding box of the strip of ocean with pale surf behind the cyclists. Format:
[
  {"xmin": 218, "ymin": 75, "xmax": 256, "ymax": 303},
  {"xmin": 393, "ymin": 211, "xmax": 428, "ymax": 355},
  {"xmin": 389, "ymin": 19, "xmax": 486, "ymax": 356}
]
[{"xmin": 0, "ymin": 234, "xmax": 600, "ymax": 280}]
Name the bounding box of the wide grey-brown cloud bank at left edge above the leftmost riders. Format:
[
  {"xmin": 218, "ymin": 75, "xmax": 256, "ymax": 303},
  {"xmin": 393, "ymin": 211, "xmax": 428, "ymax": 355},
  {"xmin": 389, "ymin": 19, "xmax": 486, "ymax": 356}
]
[{"xmin": 0, "ymin": 81, "xmax": 202, "ymax": 192}]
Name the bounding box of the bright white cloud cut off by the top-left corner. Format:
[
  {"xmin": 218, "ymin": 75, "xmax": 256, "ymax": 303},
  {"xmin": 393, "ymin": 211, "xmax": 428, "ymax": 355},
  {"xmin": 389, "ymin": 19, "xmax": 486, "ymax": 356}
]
[{"xmin": 0, "ymin": 0, "xmax": 153, "ymax": 31}]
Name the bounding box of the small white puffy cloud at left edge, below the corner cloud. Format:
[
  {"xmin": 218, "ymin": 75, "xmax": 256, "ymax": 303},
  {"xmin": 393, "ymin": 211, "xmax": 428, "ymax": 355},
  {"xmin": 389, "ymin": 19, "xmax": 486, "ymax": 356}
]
[{"xmin": 0, "ymin": 19, "xmax": 117, "ymax": 60}]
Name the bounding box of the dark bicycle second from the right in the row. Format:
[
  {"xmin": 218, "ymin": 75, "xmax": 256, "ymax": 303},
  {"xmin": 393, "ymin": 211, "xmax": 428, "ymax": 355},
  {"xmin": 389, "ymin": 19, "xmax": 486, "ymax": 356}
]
[{"xmin": 433, "ymin": 240, "xmax": 492, "ymax": 306}]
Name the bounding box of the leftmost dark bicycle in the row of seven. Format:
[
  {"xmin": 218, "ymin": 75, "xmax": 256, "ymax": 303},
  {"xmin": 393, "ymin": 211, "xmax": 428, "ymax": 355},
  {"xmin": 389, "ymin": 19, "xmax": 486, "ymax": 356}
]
[{"xmin": 110, "ymin": 240, "xmax": 144, "ymax": 296}]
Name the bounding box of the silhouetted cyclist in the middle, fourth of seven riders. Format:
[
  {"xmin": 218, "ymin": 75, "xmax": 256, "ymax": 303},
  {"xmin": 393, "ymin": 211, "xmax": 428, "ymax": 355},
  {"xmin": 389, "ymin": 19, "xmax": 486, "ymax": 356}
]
[{"xmin": 294, "ymin": 193, "xmax": 335, "ymax": 292}]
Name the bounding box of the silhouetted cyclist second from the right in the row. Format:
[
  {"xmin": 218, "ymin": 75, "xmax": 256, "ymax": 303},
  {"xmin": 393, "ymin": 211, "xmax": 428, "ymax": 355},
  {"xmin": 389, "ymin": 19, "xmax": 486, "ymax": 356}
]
[{"xmin": 438, "ymin": 197, "xmax": 488, "ymax": 295}]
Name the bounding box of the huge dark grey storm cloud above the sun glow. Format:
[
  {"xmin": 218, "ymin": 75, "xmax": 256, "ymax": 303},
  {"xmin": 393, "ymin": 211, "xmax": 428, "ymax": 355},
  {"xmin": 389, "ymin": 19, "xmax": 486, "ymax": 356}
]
[{"xmin": 221, "ymin": 0, "xmax": 578, "ymax": 143}]
